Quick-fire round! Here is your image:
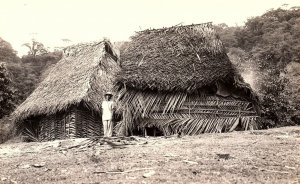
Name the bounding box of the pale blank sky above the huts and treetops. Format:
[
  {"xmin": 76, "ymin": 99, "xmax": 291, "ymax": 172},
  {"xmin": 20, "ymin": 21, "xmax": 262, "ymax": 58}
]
[{"xmin": 0, "ymin": 0, "xmax": 300, "ymax": 55}]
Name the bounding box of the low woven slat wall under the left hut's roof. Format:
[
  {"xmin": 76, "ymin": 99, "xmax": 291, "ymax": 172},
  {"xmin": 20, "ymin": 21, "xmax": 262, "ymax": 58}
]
[{"xmin": 26, "ymin": 107, "xmax": 103, "ymax": 141}]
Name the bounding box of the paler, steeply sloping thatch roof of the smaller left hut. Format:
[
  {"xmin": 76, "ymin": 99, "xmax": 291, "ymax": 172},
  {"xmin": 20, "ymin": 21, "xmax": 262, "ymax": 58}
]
[{"xmin": 14, "ymin": 40, "xmax": 119, "ymax": 120}]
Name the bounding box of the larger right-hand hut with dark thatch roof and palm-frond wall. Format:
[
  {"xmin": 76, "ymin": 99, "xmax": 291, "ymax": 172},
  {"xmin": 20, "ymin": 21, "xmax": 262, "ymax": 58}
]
[{"xmin": 116, "ymin": 23, "xmax": 257, "ymax": 134}]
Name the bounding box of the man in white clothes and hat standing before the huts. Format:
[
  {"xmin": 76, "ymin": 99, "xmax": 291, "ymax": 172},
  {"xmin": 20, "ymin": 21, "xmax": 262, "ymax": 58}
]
[{"xmin": 102, "ymin": 92, "xmax": 114, "ymax": 137}]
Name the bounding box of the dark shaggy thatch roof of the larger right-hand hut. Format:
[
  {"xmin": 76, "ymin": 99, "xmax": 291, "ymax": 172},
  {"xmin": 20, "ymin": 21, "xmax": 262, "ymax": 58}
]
[{"xmin": 117, "ymin": 23, "xmax": 247, "ymax": 92}]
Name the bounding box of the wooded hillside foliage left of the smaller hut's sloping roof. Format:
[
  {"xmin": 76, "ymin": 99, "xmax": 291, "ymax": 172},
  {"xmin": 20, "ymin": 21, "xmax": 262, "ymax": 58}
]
[{"xmin": 0, "ymin": 38, "xmax": 62, "ymax": 108}]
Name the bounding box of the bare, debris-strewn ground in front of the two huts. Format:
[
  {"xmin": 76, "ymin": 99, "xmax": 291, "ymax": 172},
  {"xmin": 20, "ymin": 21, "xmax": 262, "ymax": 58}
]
[{"xmin": 0, "ymin": 127, "xmax": 300, "ymax": 184}]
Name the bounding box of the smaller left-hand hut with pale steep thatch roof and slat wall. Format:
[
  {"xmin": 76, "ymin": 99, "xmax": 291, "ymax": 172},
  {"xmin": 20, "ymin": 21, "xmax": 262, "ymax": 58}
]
[{"xmin": 14, "ymin": 40, "xmax": 119, "ymax": 140}]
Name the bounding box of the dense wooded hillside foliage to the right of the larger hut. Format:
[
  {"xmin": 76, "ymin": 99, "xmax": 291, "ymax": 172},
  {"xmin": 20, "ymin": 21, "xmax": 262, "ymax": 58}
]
[{"xmin": 216, "ymin": 8, "xmax": 300, "ymax": 127}]
